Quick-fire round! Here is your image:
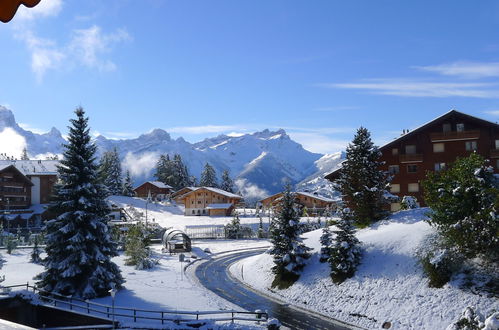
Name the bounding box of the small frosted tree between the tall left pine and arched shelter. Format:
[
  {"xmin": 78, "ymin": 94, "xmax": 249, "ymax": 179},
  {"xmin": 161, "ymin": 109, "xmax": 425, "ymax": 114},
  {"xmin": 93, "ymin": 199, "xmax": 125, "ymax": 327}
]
[{"xmin": 125, "ymin": 223, "xmax": 157, "ymax": 270}]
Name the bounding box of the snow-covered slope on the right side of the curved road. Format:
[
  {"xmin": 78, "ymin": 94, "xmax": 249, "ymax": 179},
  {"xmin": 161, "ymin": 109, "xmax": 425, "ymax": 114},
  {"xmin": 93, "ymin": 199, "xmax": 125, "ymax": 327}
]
[{"xmin": 231, "ymin": 209, "xmax": 499, "ymax": 330}]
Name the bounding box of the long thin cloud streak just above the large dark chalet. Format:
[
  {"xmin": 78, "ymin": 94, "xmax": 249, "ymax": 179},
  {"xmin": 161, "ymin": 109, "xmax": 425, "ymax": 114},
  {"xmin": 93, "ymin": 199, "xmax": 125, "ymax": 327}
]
[{"xmin": 324, "ymin": 79, "xmax": 499, "ymax": 98}]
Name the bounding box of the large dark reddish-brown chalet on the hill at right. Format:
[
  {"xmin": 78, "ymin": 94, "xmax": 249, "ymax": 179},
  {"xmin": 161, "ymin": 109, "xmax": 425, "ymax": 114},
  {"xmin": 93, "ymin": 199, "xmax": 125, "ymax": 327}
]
[{"xmin": 326, "ymin": 110, "xmax": 499, "ymax": 211}]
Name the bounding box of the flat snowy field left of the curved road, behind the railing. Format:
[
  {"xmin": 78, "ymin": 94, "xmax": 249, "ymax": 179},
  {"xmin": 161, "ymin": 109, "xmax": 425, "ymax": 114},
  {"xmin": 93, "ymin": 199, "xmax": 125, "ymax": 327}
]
[{"xmin": 0, "ymin": 240, "xmax": 268, "ymax": 329}]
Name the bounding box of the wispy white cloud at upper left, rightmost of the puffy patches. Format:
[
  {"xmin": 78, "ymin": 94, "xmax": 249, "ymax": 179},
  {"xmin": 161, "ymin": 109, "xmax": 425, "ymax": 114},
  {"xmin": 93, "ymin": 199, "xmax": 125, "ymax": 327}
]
[{"xmin": 68, "ymin": 25, "xmax": 131, "ymax": 71}]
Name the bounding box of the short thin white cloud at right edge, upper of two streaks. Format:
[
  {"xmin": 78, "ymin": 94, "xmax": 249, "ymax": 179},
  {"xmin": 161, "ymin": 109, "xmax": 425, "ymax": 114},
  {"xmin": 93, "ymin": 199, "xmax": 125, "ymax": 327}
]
[{"xmin": 416, "ymin": 62, "xmax": 499, "ymax": 78}]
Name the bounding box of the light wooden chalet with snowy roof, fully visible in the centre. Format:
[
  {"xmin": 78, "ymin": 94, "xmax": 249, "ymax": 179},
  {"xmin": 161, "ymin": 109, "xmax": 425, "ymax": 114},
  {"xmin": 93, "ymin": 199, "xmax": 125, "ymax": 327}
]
[{"xmin": 181, "ymin": 187, "xmax": 242, "ymax": 216}]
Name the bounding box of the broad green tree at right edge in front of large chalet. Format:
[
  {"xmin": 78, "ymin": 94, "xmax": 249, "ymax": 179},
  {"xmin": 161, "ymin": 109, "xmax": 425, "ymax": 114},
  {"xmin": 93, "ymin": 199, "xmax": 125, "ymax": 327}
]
[{"xmin": 423, "ymin": 154, "xmax": 499, "ymax": 263}]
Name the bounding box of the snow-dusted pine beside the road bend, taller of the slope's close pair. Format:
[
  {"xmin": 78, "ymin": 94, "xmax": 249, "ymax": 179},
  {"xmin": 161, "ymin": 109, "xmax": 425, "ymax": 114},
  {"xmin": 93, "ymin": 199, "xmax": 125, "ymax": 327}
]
[{"xmin": 270, "ymin": 184, "xmax": 310, "ymax": 289}]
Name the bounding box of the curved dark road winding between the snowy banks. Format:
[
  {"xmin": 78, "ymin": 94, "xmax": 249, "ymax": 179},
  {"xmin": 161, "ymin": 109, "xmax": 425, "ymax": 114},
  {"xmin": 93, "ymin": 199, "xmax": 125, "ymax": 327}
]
[{"xmin": 195, "ymin": 249, "xmax": 351, "ymax": 330}]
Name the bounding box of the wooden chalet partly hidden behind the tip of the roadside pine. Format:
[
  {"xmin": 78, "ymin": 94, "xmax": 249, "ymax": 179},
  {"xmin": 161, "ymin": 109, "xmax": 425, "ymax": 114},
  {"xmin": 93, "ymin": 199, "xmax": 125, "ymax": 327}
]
[{"xmin": 260, "ymin": 191, "xmax": 336, "ymax": 215}]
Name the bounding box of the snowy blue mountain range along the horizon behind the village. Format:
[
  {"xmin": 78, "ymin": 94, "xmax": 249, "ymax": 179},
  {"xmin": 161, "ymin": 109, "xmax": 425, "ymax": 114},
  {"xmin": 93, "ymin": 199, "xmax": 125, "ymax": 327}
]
[{"xmin": 0, "ymin": 106, "xmax": 344, "ymax": 200}]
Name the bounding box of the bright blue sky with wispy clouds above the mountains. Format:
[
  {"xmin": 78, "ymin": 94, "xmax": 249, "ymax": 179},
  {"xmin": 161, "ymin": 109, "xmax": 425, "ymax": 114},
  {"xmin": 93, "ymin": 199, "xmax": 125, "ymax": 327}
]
[{"xmin": 0, "ymin": 0, "xmax": 499, "ymax": 153}]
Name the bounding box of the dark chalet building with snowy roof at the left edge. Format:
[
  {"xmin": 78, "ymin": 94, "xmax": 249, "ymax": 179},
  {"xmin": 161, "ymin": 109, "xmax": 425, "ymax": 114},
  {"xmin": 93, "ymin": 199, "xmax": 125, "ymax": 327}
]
[{"xmin": 0, "ymin": 160, "xmax": 59, "ymax": 230}]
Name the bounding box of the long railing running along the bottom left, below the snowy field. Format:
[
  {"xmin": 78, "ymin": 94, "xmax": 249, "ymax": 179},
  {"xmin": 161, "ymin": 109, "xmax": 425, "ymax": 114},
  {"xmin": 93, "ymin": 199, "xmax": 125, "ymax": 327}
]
[{"xmin": 1, "ymin": 282, "xmax": 268, "ymax": 324}]
